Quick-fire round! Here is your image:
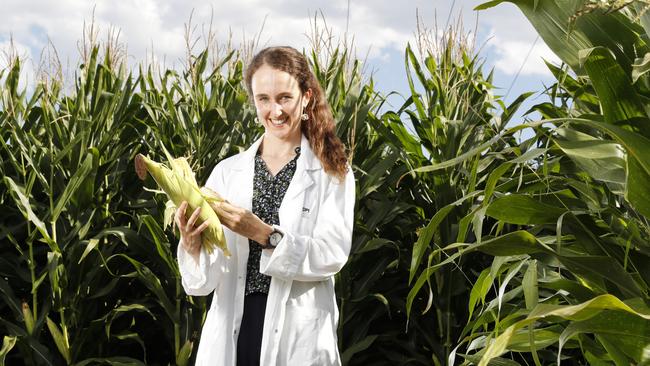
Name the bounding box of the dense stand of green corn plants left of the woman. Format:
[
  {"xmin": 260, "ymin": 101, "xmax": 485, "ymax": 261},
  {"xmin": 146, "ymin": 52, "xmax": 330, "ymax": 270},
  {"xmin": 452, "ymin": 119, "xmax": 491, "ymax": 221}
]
[{"xmin": 0, "ymin": 38, "xmax": 258, "ymax": 365}]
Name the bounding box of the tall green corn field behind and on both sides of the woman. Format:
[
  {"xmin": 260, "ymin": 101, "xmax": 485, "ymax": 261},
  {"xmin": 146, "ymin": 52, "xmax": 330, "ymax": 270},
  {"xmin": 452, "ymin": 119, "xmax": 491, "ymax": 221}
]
[{"xmin": 0, "ymin": 0, "xmax": 650, "ymax": 366}]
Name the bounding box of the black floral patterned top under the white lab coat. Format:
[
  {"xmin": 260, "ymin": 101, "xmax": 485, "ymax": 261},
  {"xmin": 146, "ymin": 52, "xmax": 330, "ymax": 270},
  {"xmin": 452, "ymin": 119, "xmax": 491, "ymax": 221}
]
[{"xmin": 245, "ymin": 147, "xmax": 300, "ymax": 295}]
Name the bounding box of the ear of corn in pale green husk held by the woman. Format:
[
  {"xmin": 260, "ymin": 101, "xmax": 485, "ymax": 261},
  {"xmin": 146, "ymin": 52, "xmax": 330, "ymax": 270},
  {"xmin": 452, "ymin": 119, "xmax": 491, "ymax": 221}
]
[{"xmin": 135, "ymin": 147, "xmax": 230, "ymax": 257}]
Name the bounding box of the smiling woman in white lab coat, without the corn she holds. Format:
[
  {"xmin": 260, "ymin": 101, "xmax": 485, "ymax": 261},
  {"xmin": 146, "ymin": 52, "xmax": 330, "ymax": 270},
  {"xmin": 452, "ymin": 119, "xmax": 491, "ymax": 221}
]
[{"xmin": 176, "ymin": 47, "xmax": 355, "ymax": 366}]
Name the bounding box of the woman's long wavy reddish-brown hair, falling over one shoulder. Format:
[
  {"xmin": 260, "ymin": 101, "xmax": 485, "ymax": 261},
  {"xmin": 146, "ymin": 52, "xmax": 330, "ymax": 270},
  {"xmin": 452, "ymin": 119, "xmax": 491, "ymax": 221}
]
[{"xmin": 244, "ymin": 47, "xmax": 348, "ymax": 181}]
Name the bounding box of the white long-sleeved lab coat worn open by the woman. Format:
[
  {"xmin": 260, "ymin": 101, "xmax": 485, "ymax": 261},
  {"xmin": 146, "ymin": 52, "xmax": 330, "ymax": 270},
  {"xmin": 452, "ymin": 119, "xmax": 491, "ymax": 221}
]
[{"xmin": 178, "ymin": 136, "xmax": 355, "ymax": 366}]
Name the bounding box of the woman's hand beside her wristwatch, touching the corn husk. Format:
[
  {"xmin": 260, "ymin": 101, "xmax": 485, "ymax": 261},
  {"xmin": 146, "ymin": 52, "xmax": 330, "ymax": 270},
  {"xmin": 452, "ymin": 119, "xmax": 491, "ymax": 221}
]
[{"xmin": 212, "ymin": 201, "xmax": 273, "ymax": 246}]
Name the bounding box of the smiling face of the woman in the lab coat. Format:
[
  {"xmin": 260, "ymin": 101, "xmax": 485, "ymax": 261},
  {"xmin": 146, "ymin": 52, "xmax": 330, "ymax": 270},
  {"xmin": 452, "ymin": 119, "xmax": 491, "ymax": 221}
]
[{"xmin": 251, "ymin": 65, "xmax": 311, "ymax": 143}]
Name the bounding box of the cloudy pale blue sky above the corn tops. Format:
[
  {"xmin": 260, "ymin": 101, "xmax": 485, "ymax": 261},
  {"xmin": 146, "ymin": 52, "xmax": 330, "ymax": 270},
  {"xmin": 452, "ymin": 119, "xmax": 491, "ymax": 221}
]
[{"xmin": 0, "ymin": 0, "xmax": 558, "ymax": 126}]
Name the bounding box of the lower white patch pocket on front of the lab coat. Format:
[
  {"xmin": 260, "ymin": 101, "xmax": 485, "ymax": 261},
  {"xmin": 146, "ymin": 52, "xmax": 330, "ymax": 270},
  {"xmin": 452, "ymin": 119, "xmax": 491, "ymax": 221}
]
[{"xmin": 279, "ymin": 305, "xmax": 327, "ymax": 365}]
